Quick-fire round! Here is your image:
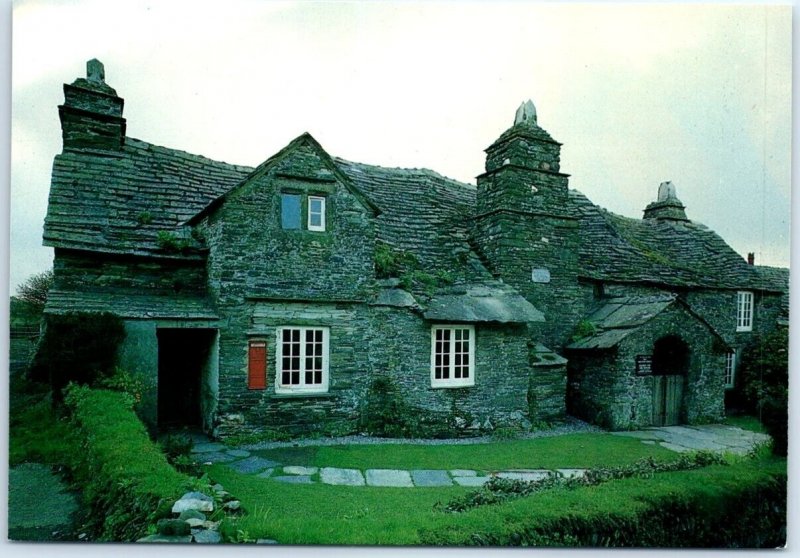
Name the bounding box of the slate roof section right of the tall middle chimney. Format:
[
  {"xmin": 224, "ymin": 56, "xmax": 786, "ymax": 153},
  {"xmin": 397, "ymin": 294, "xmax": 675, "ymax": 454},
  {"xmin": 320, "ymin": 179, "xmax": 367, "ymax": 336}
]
[{"xmin": 570, "ymin": 190, "xmax": 769, "ymax": 289}]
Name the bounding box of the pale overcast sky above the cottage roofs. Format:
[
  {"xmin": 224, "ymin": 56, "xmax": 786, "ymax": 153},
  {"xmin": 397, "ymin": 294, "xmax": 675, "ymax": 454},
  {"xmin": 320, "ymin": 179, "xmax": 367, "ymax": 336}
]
[{"xmin": 10, "ymin": 0, "xmax": 792, "ymax": 292}]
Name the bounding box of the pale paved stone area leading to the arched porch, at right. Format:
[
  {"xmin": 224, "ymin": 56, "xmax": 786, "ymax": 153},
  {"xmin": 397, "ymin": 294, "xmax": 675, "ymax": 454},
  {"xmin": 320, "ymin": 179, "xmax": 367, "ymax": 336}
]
[{"xmin": 612, "ymin": 424, "xmax": 770, "ymax": 455}]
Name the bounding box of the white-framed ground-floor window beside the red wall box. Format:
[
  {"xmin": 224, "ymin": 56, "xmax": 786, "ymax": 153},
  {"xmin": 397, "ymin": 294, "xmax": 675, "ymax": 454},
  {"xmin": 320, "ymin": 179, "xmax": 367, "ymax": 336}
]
[{"xmin": 275, "ymin": 326, "xmax": 330, "ymax": 393}]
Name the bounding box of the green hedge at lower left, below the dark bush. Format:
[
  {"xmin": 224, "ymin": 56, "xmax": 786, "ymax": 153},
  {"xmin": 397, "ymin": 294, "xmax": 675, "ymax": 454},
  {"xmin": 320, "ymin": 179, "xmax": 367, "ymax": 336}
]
[{"xmin": 65, "ymin": 384, "xmax": 196, "ymax": 542}]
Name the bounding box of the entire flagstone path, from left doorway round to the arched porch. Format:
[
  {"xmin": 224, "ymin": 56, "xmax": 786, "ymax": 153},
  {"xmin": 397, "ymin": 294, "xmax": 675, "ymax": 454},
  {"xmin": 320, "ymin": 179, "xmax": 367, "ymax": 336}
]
[{"xmin": 192, "ymin": 424, "xmax": 769, "ymax": 488}]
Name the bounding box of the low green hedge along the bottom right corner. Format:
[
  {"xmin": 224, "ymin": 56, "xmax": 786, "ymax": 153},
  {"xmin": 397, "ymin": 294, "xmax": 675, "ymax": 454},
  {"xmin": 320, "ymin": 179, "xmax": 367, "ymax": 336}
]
[{"xmin": 420, "ymin": 460, "xmax": 786, "ymax": 548}]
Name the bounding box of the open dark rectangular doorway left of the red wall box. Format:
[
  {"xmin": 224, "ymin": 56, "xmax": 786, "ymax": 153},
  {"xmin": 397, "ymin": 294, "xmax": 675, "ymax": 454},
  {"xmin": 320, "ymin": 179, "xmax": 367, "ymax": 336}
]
[{"xmin": 157, "ymin": 328, "xmax": 216, "ymax": 429}]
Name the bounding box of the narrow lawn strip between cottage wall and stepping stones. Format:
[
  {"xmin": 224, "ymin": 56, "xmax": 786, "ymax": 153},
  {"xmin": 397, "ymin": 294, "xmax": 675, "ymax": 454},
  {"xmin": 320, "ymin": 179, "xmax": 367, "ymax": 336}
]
[{"xmin": 253, "ymin": 433, "xmax": 675, "ymax": 471}]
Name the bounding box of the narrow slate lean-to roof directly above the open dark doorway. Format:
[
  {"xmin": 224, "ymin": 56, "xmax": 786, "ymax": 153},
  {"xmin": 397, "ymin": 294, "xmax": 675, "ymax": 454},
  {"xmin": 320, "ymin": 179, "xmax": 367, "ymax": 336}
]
[{"xmin": 44, "ymin": 289, "xmax": 219, "ymax": 320}]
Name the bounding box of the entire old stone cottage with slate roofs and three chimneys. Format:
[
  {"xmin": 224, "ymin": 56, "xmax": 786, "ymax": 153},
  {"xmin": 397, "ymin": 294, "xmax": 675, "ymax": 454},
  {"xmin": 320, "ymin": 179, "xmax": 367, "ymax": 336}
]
[{"xmin": 44, "ymin": 60, "xmax": 781, "ymax": 436}]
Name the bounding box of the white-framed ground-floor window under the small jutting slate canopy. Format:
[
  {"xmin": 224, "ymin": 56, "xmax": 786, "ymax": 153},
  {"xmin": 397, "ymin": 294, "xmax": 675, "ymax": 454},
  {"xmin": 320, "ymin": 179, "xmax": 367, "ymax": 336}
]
[{"xmin": 431, "ymin": 325, "xmax": 475, "ymax": 387}]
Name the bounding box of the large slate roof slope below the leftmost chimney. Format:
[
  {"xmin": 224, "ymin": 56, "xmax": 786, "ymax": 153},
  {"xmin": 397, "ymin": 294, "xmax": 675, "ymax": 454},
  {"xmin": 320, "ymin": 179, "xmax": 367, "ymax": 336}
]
[{"xmin": 44, "ymin": 138, "xmax": 251, "ymax": 257}]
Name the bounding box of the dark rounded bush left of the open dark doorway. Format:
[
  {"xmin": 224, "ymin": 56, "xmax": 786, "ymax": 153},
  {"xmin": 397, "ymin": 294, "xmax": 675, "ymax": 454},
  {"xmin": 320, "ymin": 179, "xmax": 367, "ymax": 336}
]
[{"xmin": 31, "ymin": 312, "xmax": 125, "ymax": 403}]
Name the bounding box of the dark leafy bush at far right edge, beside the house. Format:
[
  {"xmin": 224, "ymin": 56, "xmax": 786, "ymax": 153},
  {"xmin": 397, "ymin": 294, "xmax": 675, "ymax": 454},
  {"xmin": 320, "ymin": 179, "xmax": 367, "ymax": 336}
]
[{"xmin": 740, "ymin": 328, "xmax": 789, "ymax": 456}]
